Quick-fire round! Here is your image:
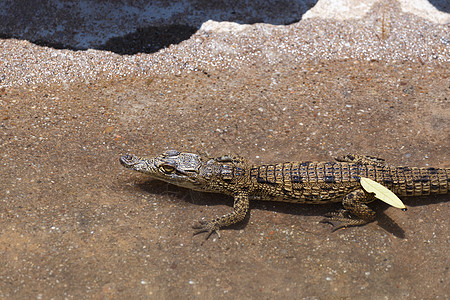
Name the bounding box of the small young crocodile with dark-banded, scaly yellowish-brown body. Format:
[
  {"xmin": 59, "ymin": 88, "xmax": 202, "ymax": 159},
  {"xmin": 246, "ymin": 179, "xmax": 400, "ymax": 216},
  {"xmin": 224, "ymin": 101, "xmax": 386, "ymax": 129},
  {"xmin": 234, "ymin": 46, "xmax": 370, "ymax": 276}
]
[{"xmin": 120, "ymin": 150, "xmax": 450, "ymax": 239}]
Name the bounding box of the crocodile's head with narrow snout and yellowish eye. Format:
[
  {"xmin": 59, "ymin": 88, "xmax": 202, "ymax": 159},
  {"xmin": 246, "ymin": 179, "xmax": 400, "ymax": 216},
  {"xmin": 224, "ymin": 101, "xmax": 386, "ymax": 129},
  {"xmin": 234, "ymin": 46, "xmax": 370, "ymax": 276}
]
[{"xmin": 120, "ymin": 150, "xmax": 209, "ymax": 190}]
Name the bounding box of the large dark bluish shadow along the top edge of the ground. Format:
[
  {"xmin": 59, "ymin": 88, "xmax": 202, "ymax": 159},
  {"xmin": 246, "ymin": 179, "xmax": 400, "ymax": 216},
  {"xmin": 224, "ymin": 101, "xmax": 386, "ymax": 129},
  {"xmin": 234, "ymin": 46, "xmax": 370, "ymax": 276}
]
[{"xmin": 0, "ymin": 0, "xmax": 317, "ymax": 54}]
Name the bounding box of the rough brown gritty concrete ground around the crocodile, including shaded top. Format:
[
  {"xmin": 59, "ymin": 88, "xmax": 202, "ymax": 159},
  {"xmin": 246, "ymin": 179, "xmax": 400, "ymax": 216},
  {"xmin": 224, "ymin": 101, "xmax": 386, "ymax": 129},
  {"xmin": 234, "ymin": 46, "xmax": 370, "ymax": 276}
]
[{"xmin": 0, "ymin": 1, "xmax": 450, "ymax": 299}]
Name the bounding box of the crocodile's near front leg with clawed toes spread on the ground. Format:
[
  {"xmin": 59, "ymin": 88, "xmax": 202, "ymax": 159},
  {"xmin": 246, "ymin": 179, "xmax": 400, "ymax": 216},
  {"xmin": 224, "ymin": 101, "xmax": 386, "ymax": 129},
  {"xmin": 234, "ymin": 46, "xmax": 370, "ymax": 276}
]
[{"xmin": 193, "ymin": 191, "xmax": 249, "ymax": 239}]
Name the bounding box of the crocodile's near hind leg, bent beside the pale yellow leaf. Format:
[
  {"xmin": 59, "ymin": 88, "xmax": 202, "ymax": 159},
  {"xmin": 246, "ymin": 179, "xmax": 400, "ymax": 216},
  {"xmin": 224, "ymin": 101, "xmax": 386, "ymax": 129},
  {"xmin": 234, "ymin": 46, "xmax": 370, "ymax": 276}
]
[{"xmin": 321, "ymin": 189, "xmax": 375, "ymax": 231}]
